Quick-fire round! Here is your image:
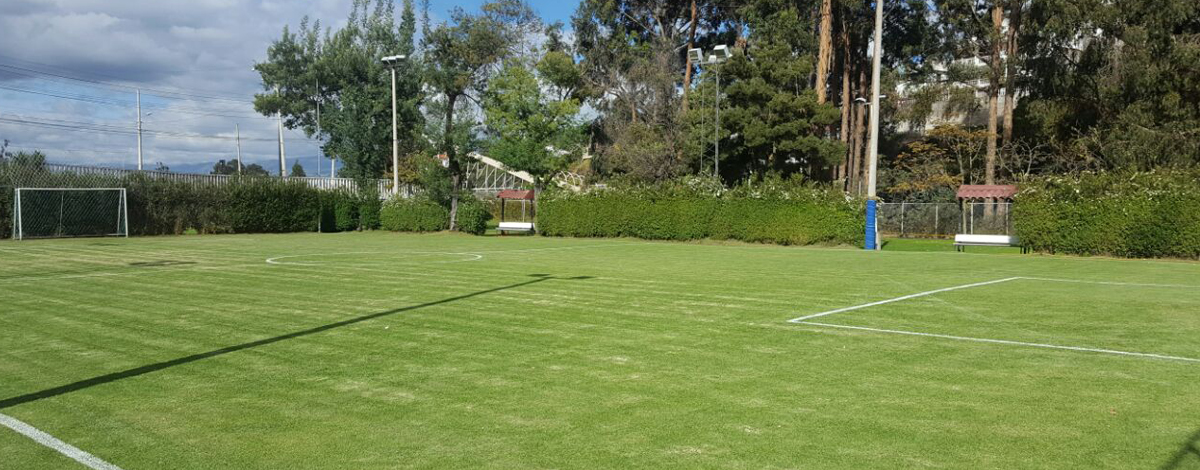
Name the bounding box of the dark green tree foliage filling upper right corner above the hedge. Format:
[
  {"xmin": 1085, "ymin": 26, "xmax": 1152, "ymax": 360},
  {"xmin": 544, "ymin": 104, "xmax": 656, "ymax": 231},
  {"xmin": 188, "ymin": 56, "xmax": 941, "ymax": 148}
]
[{"xmin": 1015, "ymin": 0, "xmax": 1200, "ymax": 170}]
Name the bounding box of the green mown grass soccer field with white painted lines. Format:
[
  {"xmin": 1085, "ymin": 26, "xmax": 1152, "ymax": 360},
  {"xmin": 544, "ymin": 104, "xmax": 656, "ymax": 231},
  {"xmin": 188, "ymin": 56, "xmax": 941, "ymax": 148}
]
[{"xmin": 0, "ymin": 233, "xmax": 1200, "ymax": 470}]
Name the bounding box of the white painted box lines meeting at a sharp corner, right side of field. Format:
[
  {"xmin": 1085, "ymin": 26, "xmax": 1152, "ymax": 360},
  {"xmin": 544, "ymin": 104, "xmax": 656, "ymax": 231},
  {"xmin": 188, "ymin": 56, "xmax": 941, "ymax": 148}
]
[{"xmin": 787, "ymin": 276, "xmax": 1200, "ymax": 362}]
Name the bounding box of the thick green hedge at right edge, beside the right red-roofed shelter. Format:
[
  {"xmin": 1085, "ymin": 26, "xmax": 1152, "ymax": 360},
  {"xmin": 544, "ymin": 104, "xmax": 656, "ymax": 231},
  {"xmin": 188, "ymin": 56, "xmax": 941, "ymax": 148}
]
[{"xmin": 1013, "ymin": 170, "xmax": 1200, "ymax": 258}]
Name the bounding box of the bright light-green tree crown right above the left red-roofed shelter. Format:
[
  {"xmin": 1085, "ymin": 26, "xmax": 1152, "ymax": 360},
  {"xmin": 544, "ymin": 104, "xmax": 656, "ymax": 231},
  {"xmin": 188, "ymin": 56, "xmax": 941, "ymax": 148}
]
[{"xmin": 482, "ymin": 60, "xmax": 583, "ymax": 188}]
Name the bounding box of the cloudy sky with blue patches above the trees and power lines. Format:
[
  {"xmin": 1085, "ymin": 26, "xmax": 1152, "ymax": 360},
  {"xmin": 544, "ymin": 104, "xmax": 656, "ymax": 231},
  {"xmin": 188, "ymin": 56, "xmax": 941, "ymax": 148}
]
[{"xmin": 0, "ymin": 0, "xmax": 576, "ymax": 175}]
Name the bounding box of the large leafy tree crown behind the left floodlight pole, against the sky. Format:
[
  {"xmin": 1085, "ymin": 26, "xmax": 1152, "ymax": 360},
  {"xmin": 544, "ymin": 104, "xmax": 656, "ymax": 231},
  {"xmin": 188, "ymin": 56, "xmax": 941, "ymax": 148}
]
[{"xmin": 254, "ymin": 0, "xmax": 425, "ymax": 179}]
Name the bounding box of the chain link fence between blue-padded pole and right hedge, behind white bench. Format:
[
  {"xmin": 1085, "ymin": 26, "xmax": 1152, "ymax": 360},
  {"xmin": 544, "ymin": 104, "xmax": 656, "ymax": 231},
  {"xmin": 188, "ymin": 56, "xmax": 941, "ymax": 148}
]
[{"xmin": 876, "ymin": 203, "xmax": 1013, "ymax": 239}]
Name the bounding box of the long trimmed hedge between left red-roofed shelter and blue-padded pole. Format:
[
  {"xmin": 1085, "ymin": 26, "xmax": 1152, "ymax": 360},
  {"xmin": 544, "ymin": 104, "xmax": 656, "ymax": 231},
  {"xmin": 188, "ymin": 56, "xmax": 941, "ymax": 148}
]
[{"xmin": 538, "ymin": 173, "xmax": 864, "ymax": 245}]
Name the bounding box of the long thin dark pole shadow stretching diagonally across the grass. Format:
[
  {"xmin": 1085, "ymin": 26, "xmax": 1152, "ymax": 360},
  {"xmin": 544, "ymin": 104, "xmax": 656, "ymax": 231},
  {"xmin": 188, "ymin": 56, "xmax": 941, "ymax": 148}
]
[{"xmin": 0, "ymin": 275, "xmax": 592, "ymax": 410}]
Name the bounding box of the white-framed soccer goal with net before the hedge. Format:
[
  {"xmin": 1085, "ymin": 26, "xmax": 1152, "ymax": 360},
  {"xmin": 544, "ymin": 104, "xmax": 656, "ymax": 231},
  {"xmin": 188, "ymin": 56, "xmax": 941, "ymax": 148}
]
[{"xmin": 12, "ymin": 188, "xmax": 130, "ymax": 240}]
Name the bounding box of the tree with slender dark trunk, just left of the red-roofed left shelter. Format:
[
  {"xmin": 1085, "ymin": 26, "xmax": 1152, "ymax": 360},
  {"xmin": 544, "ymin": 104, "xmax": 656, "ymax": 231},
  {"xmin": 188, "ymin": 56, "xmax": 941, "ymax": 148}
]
[{"xmin": 422, "ymin": 0, "xmax": 535, "ymax": 230}]
